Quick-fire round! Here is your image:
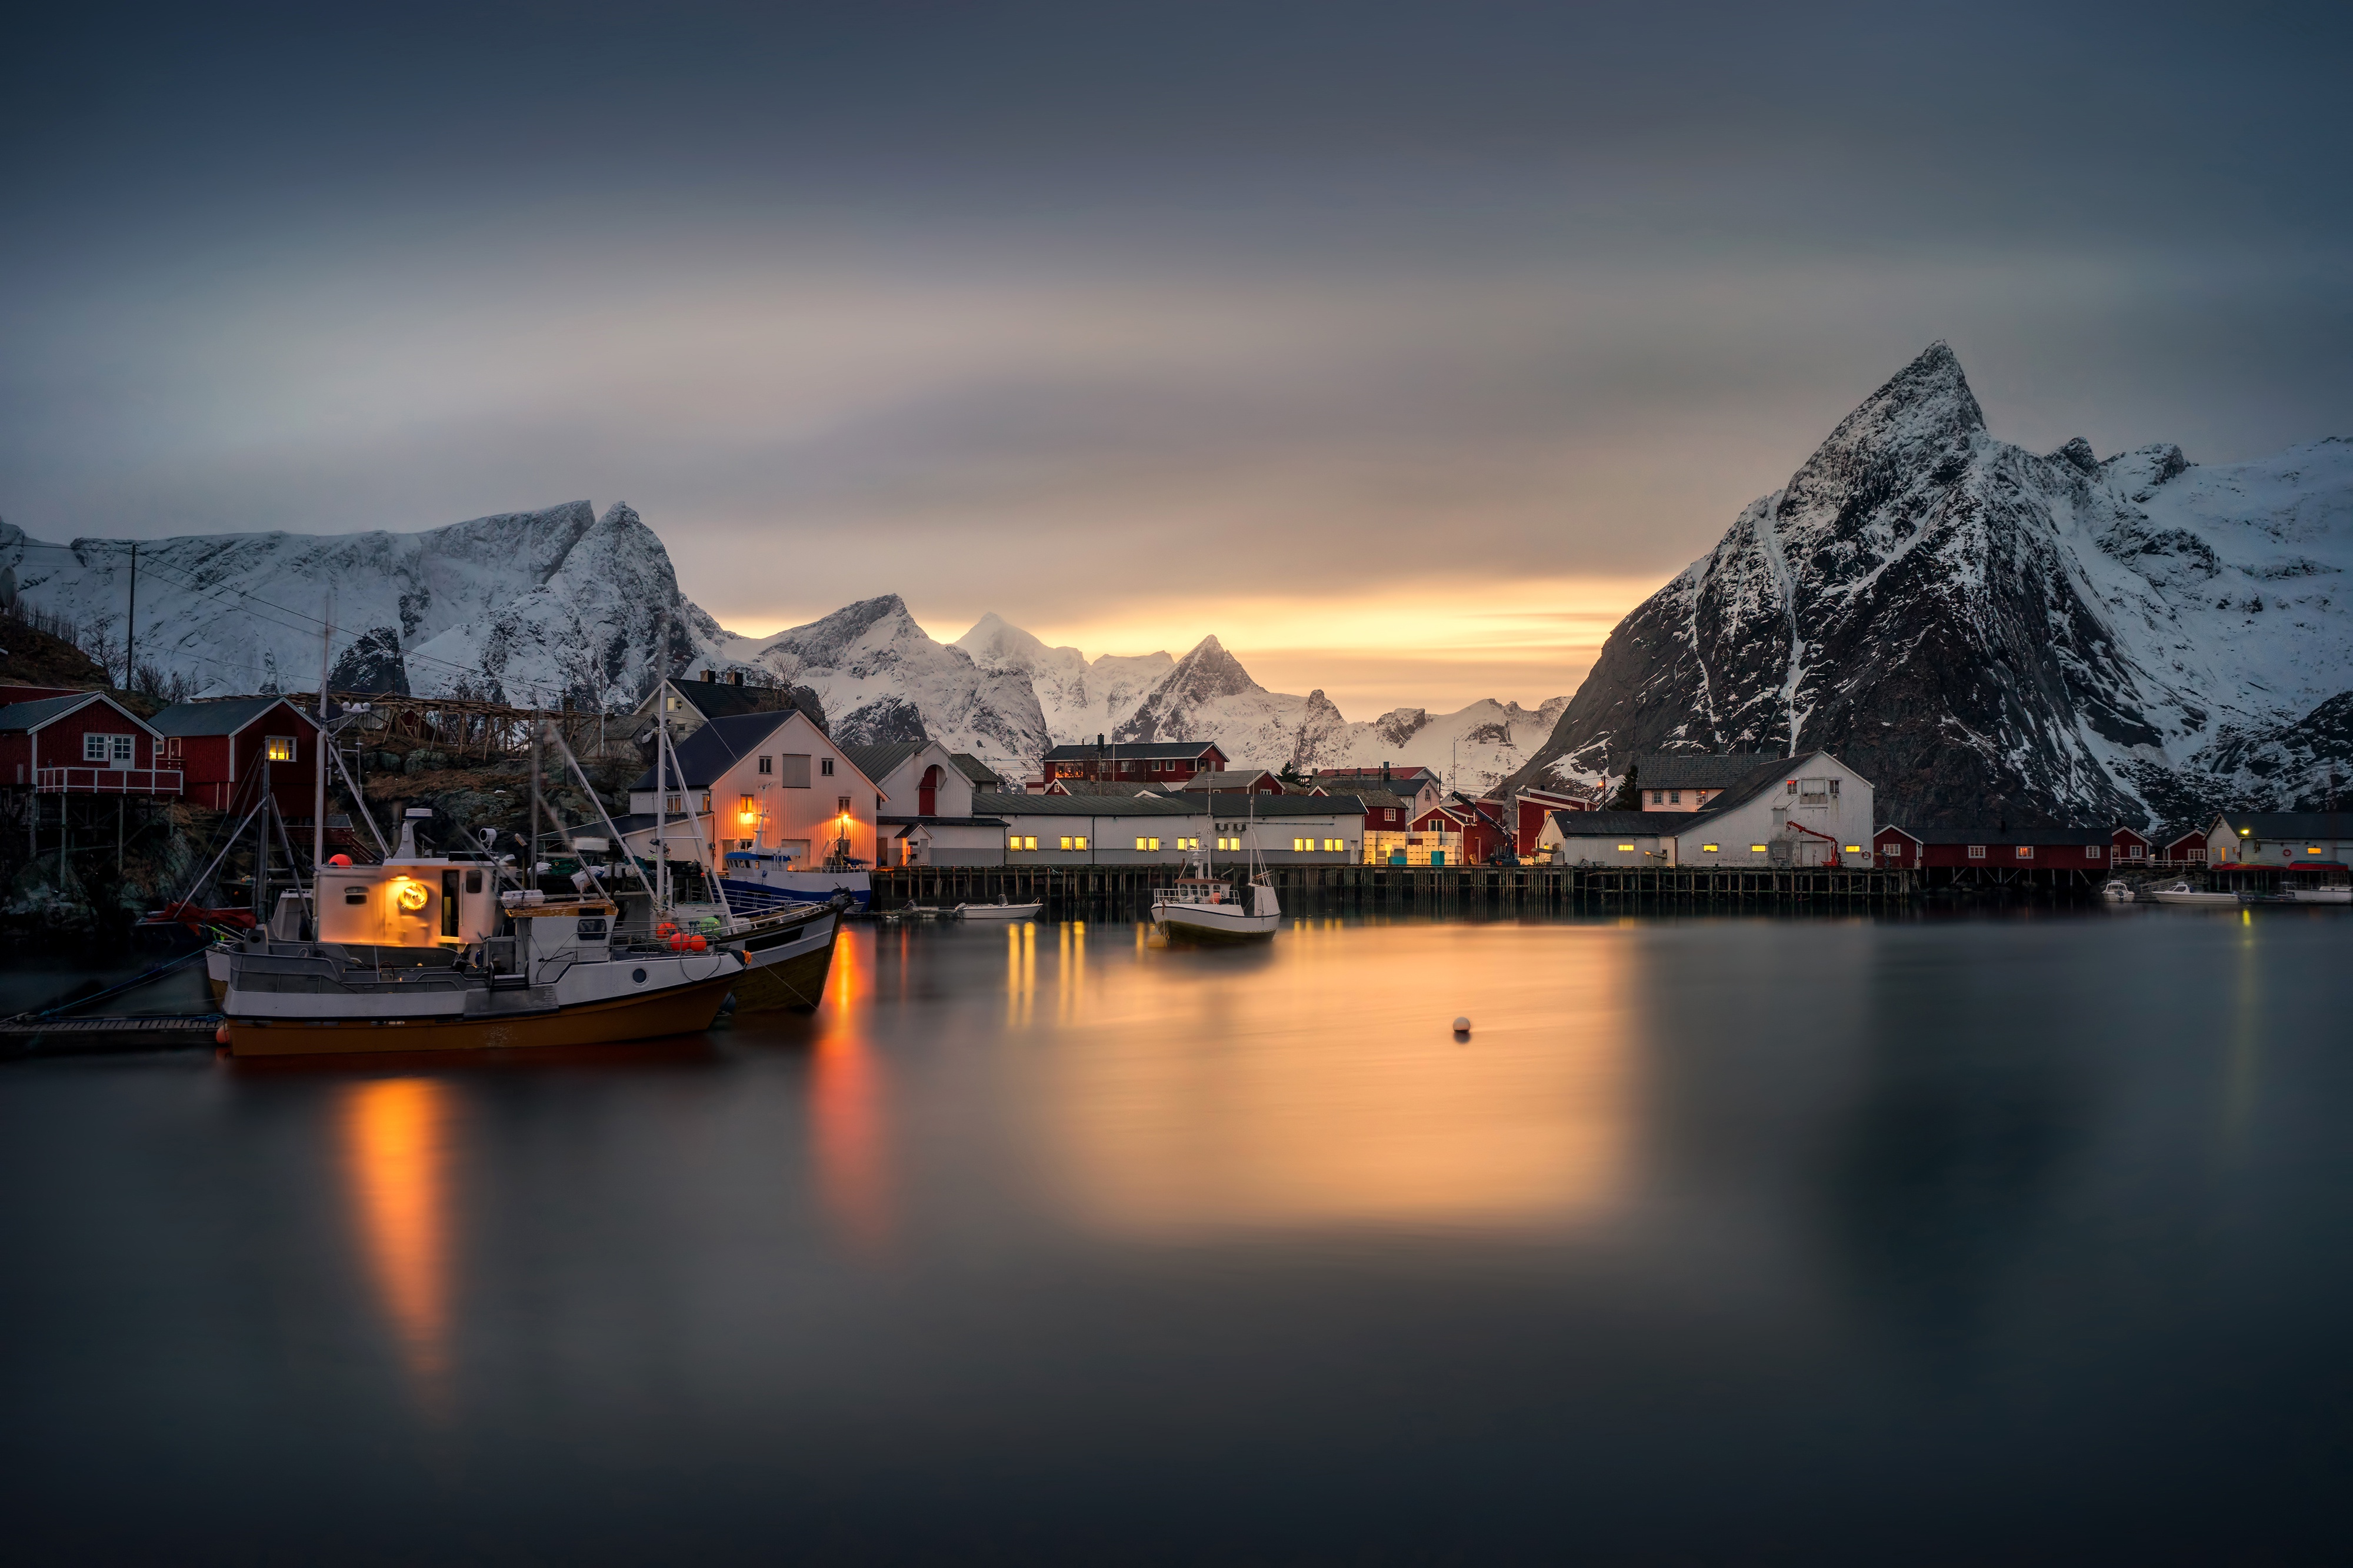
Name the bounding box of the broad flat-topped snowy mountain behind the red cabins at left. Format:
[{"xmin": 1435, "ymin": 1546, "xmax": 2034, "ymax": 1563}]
[{"xmin": 0, "ymin": 502, "xmax": 722, "ymax": 706}]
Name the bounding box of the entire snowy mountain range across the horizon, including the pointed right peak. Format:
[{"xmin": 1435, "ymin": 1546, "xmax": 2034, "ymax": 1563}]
[{"xmin": 14, "ymin": 343, "xmax": 2353, "ymax": 824}]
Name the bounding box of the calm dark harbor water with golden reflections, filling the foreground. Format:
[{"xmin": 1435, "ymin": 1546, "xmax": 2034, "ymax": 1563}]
[{"xmin": 0, "ymin": 909, "xmax": 2353, "ymax": 1563}]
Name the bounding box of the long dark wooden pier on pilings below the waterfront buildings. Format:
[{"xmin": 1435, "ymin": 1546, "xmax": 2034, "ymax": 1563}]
[{"xmin": 873, "ymin": 866, "xmax": 1920, "ymax": 918}]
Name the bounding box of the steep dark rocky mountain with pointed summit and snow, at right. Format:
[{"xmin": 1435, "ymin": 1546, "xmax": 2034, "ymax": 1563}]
[{"xmin": 1522, "ymin": 343, "xmax": 2353, "ymax": 824}]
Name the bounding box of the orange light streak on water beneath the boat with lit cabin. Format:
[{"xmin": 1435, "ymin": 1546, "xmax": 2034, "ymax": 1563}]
[{"xmin": 344, "ymin": 1078, "xmax": 449, "ymax": 1410}]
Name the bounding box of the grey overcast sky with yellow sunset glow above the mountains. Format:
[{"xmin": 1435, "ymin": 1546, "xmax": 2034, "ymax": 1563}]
[{"xmin": 0, "ymin": 0, "xmax": 2353, "ymax": 718}]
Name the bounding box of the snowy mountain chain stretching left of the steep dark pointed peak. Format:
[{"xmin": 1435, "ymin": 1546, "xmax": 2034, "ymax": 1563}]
[{"xmin": 0, "ymin": 502, "xmax": 1567, "ymax": 789}]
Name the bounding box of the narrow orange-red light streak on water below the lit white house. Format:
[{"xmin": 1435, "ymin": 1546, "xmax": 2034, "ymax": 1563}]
[{"xmin": 809, "ymin": 930, "xmax": 885, "ymax": 1253}]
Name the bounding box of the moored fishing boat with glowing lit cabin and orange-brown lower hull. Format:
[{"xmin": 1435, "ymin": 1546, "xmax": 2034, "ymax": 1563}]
[{"xmin": 221, "ymin": 824, "xmax": 746, "ymax": 1057}]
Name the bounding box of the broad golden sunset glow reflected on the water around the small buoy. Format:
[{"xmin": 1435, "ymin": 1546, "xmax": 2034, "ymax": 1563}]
[{"xmin": 1021, "ymin": 920, "xmax": 1640, "ymax": 1234}]
